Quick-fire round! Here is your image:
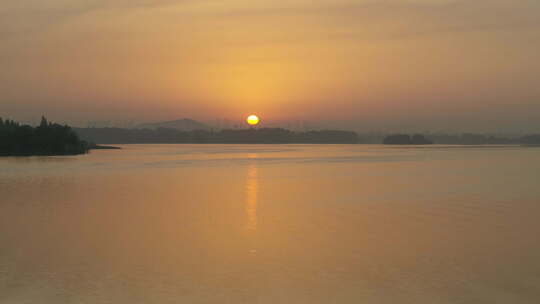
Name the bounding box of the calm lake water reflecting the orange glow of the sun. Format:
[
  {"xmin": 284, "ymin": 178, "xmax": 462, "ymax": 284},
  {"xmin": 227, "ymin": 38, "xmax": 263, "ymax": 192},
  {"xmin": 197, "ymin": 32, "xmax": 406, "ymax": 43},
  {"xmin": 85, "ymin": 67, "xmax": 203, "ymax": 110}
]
[{"xmin": 0, "ymin": 145, "xmax": 540, "ymax": 304}]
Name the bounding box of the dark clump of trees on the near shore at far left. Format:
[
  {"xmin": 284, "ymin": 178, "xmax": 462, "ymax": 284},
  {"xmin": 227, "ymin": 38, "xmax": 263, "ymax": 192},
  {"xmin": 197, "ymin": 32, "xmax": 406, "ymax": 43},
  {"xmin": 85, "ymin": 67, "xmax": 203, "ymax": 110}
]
[{"xmin": 0, "ymin": 117, "xmax": 89, "ymax": 156}]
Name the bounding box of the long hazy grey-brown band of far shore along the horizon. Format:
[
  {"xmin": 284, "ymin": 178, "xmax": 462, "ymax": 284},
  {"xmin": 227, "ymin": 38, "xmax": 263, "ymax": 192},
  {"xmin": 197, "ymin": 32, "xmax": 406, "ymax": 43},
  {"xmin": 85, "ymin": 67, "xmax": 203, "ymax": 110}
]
[{"xmin": 74, "ymin": 127, "xmax": 540, "ymax": 146}]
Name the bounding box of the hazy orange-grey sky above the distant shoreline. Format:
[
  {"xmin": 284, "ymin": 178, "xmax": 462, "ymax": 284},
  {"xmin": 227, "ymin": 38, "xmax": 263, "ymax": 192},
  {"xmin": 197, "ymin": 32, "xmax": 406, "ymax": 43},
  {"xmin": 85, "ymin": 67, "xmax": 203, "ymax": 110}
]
[{"xmin": 0, "ymin": 0, "xmax": 540, "ymax": 132}]
